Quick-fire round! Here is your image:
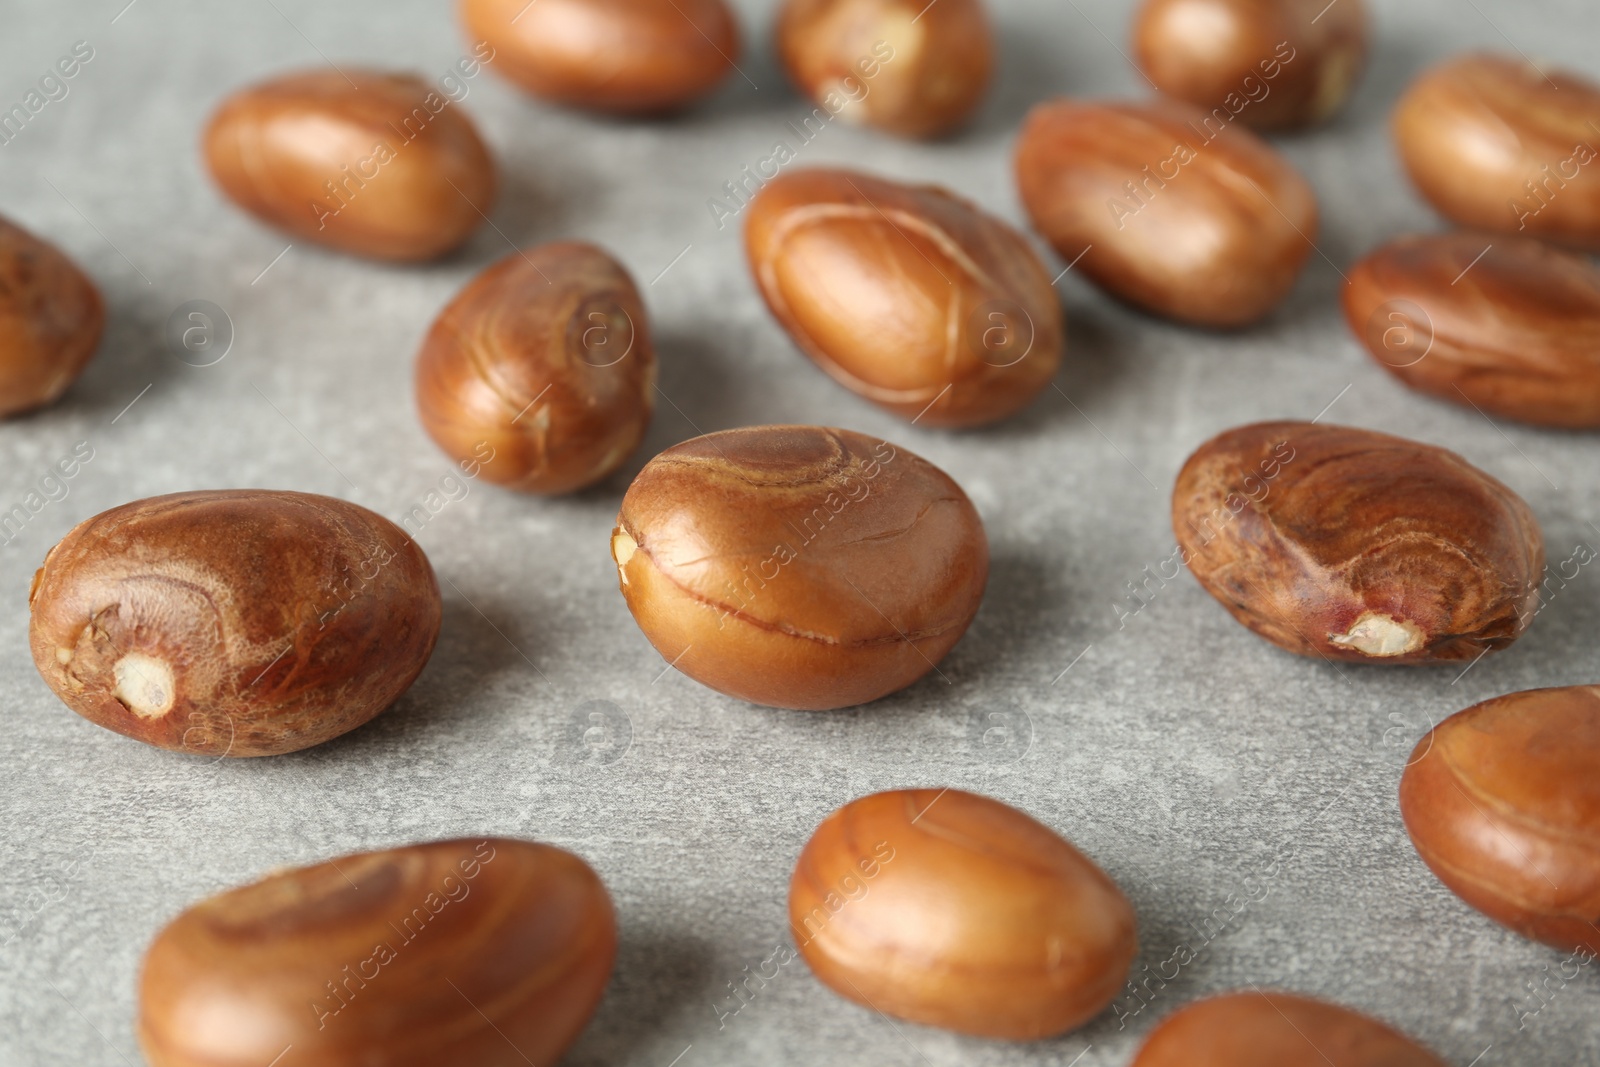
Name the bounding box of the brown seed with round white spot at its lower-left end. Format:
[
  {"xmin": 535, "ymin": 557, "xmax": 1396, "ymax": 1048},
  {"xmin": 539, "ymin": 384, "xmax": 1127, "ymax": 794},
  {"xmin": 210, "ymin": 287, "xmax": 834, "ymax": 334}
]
[{"xmin": 29, "ymin": 490, "xmax": 442, "ymax": 757}]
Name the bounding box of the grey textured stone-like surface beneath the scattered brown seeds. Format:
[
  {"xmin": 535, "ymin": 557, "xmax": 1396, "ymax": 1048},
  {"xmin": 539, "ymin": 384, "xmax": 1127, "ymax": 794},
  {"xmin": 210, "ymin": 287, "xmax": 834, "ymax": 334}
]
[{"xmin": 0, "ymin": 0, "xmax": 1600, "ymax": 1067}]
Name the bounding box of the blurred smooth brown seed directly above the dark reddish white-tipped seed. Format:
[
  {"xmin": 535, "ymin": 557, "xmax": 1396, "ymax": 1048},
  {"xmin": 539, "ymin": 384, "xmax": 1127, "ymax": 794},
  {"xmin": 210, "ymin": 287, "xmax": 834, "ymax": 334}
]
[{"xmin": 1016, "ymin": 99, "xmax": 1317, "ymax": 330}]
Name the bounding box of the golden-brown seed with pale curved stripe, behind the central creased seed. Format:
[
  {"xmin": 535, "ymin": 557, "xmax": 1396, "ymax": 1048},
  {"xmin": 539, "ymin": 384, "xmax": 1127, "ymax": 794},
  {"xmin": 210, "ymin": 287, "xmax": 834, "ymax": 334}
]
[{"xmin": 744, "ymin": 168, "xmax": 1066, "ymax": 429}]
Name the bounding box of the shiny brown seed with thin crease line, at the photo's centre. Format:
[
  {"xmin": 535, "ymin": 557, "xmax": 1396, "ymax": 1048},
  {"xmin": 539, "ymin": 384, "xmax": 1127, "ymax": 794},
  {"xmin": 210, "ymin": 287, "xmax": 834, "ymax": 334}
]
[{"xmin": 611, "ymin": 426, "xmax": 989, "ymax": 710}]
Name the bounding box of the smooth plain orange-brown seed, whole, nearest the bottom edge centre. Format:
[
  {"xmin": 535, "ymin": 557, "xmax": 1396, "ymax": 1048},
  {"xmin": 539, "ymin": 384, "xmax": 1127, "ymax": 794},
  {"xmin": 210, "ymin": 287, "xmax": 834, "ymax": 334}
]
[{"xmin": 789, "ymin": 789, "xmax": 1138, "ymax": 1041}]
